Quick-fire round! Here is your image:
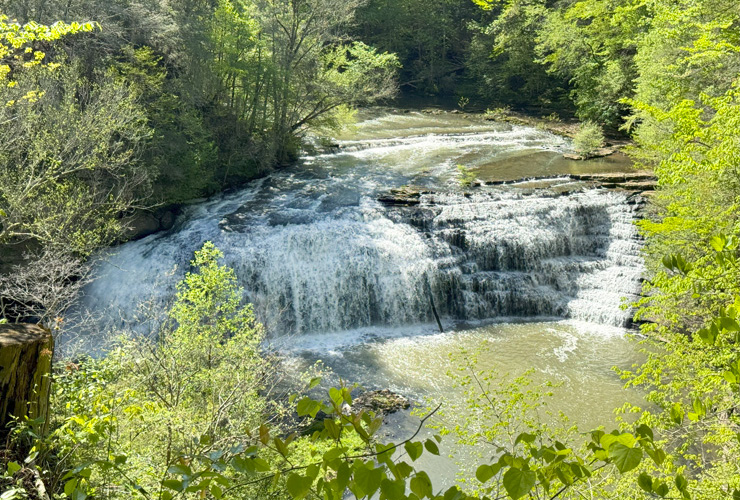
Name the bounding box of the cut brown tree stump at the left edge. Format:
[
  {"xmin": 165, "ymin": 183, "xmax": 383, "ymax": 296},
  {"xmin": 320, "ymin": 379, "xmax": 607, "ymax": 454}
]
[{"xmin": 0, "ymin": 324, "xmax": 54, "ymax": 435}]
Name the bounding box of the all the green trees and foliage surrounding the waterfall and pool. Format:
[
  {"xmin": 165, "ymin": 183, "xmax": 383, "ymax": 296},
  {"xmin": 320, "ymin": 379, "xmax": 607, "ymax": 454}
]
[{"xmin": 0, "ymin": 0, "xmax": 740, "ymax": 500}]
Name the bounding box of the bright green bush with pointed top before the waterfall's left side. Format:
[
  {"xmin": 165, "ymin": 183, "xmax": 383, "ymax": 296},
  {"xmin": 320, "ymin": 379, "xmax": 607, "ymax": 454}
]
[{"xmin": 52, "ymin": 242, "xmax": 274, "ymax": 498}]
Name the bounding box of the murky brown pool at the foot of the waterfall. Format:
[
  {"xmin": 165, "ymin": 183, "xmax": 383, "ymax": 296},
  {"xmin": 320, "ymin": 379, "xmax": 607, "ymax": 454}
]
[{"xmin": 291, "ymin": 321, "xmax": 643, "ymax": 487}]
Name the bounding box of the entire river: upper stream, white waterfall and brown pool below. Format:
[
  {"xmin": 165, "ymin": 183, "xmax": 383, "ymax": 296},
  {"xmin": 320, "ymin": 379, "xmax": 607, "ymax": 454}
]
[{"xmin": 71, "ymin": 108, "xmax": 642, "ymax": 488}]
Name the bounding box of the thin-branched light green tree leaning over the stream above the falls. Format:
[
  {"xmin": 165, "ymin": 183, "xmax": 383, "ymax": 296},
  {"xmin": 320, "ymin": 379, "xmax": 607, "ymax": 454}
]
[{"xmin": 246, "ymin": 0, "xmax": 397, "ymax": 161}]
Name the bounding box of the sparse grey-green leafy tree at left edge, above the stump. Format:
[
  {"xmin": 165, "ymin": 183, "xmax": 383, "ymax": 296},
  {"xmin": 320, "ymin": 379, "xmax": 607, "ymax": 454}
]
[{"xmin": 0, "ymin": 19, "xmax": 149, "ymax": 320}]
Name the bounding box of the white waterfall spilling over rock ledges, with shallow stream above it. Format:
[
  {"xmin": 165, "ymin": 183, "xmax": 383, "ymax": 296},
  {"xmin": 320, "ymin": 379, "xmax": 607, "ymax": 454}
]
[{"xmin": 72, "ymin": 109, "xmax": 641, "ymax": 352}]
